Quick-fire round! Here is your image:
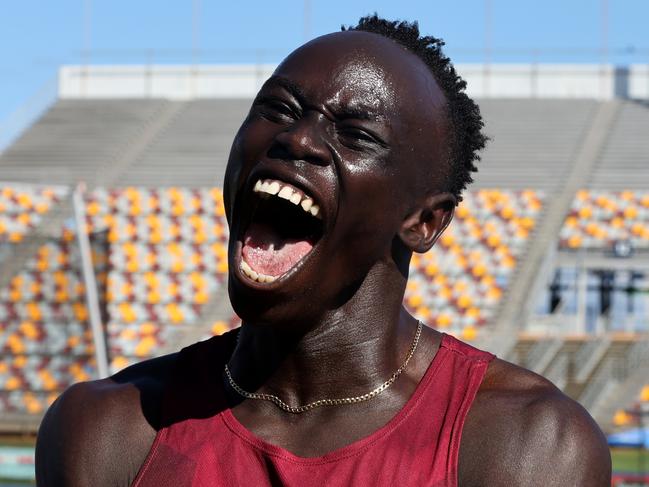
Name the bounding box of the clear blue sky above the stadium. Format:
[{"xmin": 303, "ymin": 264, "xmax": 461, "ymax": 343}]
[{"xmin": 0, "ymin": 0, "xmax": 649, "ymax": 132}]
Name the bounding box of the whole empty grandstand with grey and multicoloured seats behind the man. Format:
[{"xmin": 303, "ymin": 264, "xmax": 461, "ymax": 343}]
[{"xmin": 0, "ymin": 63, "xmax": 649, "ymax": 444}]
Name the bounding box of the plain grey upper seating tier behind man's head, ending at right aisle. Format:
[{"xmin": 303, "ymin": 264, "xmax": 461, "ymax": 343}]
[{"xmin": 0, "ymin": 99, "xmax": 612, "ymax": 193}]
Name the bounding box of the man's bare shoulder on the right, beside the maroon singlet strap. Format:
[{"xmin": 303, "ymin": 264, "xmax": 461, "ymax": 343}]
[{"xmin": 459, "ymin": 359, "xmax": 611, "ymax": 487}]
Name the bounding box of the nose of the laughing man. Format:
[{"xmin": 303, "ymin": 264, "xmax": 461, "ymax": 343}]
[{"xmin": 268, "ymin": 112, "xmax": 331, "ymax": 165}]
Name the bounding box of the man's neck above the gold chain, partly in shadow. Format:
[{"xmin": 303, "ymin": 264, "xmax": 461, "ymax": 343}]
[{"xmin": 229, "ymin": 264, "xmax": 417, "ymax": 406}]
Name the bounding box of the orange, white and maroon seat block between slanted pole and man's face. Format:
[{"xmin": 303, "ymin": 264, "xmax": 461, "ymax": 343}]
[{"xmin": 86, "ymin": 187, "xmax": 228, "ymax": 370}]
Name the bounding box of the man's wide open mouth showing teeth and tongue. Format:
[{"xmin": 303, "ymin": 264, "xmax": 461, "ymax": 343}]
[{"xmin": 240, "ymin": 179, "xmax": 324, "ymax": 283}]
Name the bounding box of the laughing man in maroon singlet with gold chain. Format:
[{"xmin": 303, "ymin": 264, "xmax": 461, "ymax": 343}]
[{"xmin": 37, "ymin": 16, "xmax": 610, "ymax": 487}]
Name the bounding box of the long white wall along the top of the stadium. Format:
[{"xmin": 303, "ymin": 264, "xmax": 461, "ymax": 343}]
[{"xmin": 59, "ymin": 64, "xmax": 649, "ymax": 100}]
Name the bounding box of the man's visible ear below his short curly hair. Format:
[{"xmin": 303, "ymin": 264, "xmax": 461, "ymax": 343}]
[{"xmin": 399, "ymin": 193, "xmax": 457, "ymax": 253}]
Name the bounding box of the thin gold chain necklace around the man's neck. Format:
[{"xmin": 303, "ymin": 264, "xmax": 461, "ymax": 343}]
[{"xmin": 225, "ymin": 321, "xmax": 423, "ymax": 414}]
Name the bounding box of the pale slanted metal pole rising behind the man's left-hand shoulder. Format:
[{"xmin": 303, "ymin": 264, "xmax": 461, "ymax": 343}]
[{"xmin": 72, "ymin": 184, "xmax": 108, "ymax": 379}]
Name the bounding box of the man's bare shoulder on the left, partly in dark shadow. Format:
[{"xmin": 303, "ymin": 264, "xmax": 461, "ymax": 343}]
[{"xmin": 36, "ymin": 354, "xmax": 176, "ymax": 486}]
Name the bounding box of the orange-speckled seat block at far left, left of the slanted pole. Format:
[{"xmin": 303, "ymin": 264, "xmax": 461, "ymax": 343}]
[{"xmin": 0, "ymin": 185, "xmax": 102, "ymax": 414}]
